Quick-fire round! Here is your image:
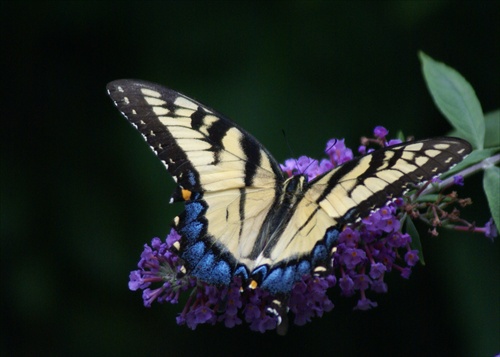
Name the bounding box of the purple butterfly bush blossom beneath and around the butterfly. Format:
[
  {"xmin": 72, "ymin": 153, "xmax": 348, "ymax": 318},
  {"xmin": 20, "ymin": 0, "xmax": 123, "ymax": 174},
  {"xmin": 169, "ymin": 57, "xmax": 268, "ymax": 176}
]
[{"xmin": 129, "ymin": 126, "xmax": 498, "ymax": 333}]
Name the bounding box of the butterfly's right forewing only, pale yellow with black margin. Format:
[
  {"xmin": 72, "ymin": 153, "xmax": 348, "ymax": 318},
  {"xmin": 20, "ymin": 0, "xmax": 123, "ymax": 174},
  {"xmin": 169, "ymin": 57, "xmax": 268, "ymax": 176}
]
[{"xmin": 306, "ymin": 137, "xmax": 472, "ymax": 224}]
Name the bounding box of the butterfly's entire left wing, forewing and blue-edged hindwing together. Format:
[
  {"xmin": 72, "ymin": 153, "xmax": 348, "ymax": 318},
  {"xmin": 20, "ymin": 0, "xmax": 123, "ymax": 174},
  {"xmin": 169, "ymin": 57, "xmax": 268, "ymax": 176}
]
[{"xmin": 107, "ymin": 80, "xmax": 283, "ymax": 284}]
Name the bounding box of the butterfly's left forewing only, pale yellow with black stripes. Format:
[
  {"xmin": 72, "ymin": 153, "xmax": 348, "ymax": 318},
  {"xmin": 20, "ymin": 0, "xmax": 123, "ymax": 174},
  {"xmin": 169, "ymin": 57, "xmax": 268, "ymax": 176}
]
[{"xmin": 107, "ymin": 80, "xmax": 282, "ymax": 199}]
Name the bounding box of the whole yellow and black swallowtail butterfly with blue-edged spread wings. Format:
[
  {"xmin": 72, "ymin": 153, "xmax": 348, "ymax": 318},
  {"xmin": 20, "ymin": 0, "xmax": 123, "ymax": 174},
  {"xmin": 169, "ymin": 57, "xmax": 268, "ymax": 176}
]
[{"xmin": 107, "ymin": 80, "xmax": 471, "ymax": 294}]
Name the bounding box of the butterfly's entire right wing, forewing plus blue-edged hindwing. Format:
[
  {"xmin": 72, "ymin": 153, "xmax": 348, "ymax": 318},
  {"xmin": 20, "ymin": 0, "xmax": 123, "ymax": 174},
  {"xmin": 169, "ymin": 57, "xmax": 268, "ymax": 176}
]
[{"xmin": 252, "ymin": 137, "xmax": 471, "ymax": 293}]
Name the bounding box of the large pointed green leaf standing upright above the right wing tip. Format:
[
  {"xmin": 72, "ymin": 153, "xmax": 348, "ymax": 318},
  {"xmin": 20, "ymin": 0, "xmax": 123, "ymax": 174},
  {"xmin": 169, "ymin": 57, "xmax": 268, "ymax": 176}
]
[{"xmin": 419, "ymin": 52, "xmax": 485, "ymax": 149}]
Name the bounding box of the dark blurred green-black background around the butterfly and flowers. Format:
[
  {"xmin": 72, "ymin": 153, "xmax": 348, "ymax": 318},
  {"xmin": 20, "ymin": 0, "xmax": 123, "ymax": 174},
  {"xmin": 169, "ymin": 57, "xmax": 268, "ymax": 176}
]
[{"xmin": 0, "ymin": 1, "xmax": 500, "ymax": 356}]
